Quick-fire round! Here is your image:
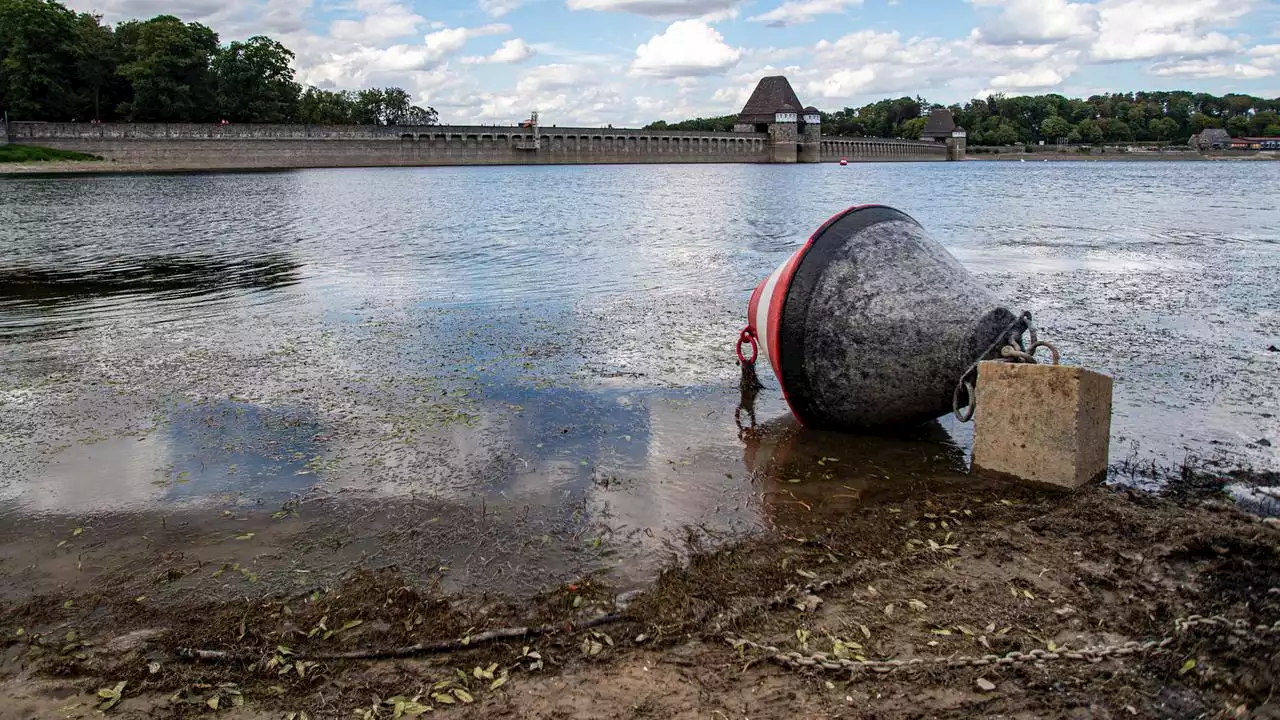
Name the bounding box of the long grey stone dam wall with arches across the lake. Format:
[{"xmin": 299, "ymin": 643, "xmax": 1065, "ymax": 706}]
[{"xmin": 9, "ymin": 122, "xmax": 946, "ymax": 169}]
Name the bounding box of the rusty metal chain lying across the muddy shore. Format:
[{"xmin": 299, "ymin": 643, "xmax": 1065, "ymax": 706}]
[{"xmin": 724, "ymin": 615, "xmax": 1280, "ymax": 673}]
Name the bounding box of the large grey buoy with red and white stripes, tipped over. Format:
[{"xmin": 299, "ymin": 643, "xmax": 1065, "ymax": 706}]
[{"xmin": 739, "ymin": 205, "xmax": 1021, "ymax": 429}]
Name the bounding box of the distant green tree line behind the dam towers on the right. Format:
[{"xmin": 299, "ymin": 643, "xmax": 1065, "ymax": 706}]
[{"xmin": 645, "ymin": 91, "xmax": 1280, "ymax": 145}]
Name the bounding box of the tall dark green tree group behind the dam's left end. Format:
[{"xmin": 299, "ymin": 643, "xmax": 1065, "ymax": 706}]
[{"xmin": 0, "ymin": 0, "xmax": 439, "ymax": 124}]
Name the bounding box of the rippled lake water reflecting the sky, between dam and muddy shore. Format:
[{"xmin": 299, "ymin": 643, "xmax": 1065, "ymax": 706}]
[{"xmin": 0, "ymin": 163, "xmax": 1280, "ymax": 588}]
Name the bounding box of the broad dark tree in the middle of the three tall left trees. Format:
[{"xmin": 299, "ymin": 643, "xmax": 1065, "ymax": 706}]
[{"xmin": 116, "ymin": 15, "xmax": 218, "ymax": 123}]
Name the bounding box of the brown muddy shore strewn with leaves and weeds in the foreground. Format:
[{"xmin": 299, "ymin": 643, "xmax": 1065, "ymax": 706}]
[{"xmin": 0, "ymin": 459, "xmax": 1280, "ymax": 717}]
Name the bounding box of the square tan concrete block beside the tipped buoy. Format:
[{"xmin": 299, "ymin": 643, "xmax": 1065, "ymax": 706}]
[{"xmin": 973, "ymin": 361, "xmax": 1112, "ymax": 488}]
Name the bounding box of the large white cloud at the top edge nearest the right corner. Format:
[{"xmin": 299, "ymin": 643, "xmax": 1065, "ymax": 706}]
[{"xmin": 1089, "ymin": 0, "xmax": 1254, "ymax": 61}]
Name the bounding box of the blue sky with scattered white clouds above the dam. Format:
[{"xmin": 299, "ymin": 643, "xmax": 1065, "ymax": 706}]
[{"xmin": 68, "ymin": 0, "xmax": 1280, "ymax": 127}]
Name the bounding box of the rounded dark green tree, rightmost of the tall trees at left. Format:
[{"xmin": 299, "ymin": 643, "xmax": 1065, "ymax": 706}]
[{"xmin": 212, "ymin": 36, "xmax": 301, "ymax": 123}]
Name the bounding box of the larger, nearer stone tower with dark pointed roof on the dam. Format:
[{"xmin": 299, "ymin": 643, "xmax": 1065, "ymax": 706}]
[{"xmin": 733, "ymin": 76, "xmax": 822, "ymax": 163}]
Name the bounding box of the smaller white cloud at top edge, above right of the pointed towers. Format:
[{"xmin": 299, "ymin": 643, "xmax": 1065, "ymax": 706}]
[{"xmin": 970, "ymin": 0, "xmax": 1098, "ymax": 45}]
